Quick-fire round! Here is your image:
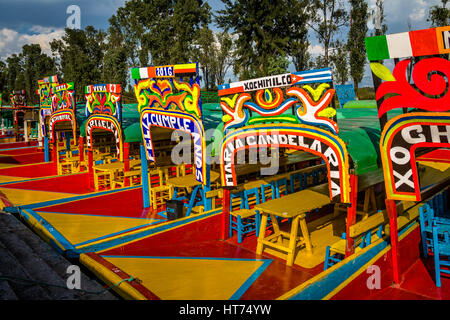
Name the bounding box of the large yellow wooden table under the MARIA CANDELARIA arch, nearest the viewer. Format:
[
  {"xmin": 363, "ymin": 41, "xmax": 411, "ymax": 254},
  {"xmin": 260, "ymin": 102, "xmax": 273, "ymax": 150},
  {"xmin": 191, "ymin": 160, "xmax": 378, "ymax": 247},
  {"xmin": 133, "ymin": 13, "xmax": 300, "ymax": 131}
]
[{"xmin": 255, "ymin": 189, "xmax": 330, "ymax": 266}]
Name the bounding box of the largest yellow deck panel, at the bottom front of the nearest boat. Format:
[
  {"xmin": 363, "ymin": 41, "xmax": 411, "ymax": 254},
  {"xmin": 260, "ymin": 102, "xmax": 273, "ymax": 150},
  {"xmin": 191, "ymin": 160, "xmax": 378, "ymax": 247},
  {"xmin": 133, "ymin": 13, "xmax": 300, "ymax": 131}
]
[{"xmin": 103, "ymin": 257, "xmax": 263, "ymax": 300}]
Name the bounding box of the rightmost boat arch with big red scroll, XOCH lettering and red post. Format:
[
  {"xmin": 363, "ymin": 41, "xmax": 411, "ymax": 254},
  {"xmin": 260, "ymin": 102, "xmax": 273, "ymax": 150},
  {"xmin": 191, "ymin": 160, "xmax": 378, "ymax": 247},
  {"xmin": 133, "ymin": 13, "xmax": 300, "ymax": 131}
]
[{"xmin": 365, "ymin": 26, "xmax": 450, "ymax": 284}]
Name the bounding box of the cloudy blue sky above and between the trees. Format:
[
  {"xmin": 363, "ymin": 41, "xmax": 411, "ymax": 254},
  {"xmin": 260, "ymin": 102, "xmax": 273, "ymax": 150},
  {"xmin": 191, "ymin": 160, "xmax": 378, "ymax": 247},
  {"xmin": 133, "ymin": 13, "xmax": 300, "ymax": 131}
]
[{"xmin": 0, "ymin": 0, "xmax": 440, "ymax": 86}]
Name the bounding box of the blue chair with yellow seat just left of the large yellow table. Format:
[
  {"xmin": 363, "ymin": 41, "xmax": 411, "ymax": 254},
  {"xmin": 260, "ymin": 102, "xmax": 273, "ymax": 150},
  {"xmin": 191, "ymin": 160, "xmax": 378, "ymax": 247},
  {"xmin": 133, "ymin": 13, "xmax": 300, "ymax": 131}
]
[{"xmin": 229, "ymin": 188, "xmax": 261, "ymax": 243}]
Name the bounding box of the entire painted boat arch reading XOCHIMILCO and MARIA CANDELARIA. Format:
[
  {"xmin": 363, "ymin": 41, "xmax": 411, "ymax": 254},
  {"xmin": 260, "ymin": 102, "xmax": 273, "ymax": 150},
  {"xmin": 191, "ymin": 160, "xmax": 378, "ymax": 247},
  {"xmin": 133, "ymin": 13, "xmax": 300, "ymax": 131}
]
[{"xmin": 219, "ymin": 69, "xmax": 350, "ymax": 203}]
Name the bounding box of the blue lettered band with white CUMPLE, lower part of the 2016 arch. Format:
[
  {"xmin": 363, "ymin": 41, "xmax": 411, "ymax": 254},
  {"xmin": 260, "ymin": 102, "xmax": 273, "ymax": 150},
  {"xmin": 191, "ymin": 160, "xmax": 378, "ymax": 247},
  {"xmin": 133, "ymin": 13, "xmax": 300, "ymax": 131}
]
[{"xmin": 141, "ymin": 110, "xmax": 205, "ymax": 183}]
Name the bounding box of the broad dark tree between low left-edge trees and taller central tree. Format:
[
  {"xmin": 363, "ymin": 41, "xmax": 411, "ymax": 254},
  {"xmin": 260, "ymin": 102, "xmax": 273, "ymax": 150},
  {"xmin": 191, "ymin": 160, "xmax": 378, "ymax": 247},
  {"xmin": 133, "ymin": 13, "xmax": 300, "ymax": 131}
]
[{"xmin": 50, "ymin": 26, "xmax": 106, "ymax": 101}]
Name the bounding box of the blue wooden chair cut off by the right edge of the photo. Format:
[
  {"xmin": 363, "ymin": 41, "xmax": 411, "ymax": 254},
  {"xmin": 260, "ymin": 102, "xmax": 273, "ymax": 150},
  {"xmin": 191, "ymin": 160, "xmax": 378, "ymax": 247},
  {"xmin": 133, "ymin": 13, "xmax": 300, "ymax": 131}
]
[{"xmin": 432, "ymin": 220, "xmax": 450, "ymax": 287}]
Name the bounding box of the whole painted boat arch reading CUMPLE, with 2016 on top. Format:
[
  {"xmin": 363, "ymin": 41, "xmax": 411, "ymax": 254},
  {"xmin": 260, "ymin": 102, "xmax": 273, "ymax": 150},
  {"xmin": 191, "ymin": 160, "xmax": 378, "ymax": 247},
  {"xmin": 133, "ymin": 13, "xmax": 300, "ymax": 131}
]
[{"xmin": 131, "ymin": 63, "xmax": 207, "ymax": 184}]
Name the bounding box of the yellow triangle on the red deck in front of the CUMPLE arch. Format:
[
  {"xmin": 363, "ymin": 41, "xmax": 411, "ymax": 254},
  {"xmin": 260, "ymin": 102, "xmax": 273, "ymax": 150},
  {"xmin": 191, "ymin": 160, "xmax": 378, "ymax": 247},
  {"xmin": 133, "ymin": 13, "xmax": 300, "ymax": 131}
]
[{"xmin": 38, "ymin": 212, "xmax": 157, "ymax": 245}]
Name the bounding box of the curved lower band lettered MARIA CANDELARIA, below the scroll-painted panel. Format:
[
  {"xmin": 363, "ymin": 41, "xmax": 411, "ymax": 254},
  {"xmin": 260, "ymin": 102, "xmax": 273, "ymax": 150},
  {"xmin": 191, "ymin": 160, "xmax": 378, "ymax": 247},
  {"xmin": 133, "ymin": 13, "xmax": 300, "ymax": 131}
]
[{"xmin": 221, "ymin": 124, "xmax": 350, "ymax": 203}]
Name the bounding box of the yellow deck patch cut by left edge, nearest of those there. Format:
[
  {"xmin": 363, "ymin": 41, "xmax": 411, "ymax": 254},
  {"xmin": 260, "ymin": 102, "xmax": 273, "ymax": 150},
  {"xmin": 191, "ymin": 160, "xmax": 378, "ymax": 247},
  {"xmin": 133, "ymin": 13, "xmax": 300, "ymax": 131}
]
[{"xmin": 0, "ymin": 188, "xmax": 74, "ymax": 206}]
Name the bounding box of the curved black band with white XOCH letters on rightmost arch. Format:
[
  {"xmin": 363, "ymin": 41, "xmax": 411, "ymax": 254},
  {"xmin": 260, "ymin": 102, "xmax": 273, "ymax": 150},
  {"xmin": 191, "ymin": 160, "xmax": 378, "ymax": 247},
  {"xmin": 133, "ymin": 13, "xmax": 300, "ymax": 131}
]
[{"xmin": 380, "ymin": 113, "xmax": 450, "ymax": 201}]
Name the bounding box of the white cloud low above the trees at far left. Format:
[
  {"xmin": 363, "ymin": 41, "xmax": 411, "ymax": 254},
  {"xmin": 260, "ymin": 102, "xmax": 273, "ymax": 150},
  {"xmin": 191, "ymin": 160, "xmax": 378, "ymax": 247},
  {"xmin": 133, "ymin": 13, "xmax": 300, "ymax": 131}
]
[{"xmin": 0, "ymin": 26, "xmax": 64, "ymax": 59}]
